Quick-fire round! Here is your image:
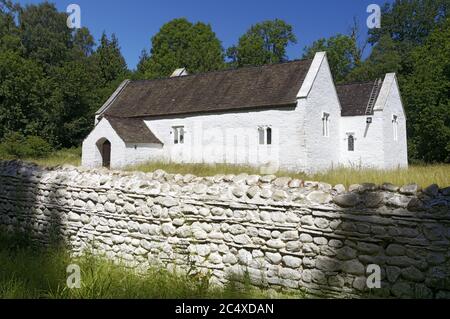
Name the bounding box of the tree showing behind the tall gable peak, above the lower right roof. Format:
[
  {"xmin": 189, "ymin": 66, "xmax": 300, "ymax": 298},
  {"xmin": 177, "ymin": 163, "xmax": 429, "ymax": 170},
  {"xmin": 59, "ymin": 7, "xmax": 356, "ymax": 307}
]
[{"xmin": 303, "ymin": 34, "xmax": 360, "ymax": 83}]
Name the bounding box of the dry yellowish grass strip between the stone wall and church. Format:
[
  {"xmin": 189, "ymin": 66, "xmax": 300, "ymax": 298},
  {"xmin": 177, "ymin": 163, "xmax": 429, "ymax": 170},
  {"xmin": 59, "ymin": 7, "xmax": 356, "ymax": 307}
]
[{"xmin": 0, "ymin": 148, "xmax": 450, "ymax": 187}]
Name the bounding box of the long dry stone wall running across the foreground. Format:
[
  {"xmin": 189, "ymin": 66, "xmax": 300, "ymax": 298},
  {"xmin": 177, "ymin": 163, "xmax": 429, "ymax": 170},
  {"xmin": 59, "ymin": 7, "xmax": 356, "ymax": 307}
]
[{"xmin": 0, "ymin": 161, "xmax": 450, "ymax": 298}]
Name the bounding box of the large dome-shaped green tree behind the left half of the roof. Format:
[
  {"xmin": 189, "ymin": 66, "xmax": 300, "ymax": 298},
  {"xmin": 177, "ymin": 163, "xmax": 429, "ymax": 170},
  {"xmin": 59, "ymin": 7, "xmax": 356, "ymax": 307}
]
[{"xmin": 139, "ymin": 18, "xmax": 224, "ymax": 79}]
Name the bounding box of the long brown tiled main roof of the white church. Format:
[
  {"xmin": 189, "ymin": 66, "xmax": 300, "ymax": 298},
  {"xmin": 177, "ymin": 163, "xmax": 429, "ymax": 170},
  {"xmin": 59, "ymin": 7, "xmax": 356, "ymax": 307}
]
[{"xmin": 105, "ymin": 60, "xmax": 312, "ymax": 117}]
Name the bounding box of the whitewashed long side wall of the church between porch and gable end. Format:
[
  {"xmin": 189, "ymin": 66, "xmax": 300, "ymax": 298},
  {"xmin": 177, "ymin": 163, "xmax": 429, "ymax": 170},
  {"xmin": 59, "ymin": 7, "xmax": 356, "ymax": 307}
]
[{"xmin": 145, "ymin": 107, "xmax": 301, "ymax": 170}]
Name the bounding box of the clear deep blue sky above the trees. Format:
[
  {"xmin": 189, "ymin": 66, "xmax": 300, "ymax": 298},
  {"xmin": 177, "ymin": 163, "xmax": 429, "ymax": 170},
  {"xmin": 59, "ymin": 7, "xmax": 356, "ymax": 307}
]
[{"xmin": 16, "ymin": 0, "xmax": 390, "ymax": 69}]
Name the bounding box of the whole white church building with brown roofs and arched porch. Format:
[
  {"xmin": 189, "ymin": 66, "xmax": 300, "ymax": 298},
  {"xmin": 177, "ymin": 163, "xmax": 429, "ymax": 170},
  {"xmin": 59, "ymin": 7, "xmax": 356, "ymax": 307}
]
[{"xmin": 82, "ymin": 52, "xmax": 408, "ymax": 172}]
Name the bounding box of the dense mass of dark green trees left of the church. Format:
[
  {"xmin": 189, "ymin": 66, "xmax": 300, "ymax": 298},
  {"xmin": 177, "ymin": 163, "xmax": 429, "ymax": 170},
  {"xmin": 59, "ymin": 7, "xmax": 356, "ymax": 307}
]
[{"xmin": 0, "ymin": 0, "xmax": 129, "ymax": 147}]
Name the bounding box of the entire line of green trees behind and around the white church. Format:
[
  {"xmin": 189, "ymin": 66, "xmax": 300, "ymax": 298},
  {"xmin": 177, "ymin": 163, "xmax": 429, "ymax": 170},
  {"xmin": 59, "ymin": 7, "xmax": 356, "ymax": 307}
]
[{"xmin": 0, "ymin": 0, "xmax": 450, "ymax": 162}]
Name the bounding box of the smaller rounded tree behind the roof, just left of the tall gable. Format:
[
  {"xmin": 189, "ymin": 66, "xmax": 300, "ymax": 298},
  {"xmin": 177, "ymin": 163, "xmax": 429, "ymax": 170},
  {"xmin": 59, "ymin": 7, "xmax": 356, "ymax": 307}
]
[{"xmin": 227, "ymin": 19, "xmax": 297, "ymax": 67}]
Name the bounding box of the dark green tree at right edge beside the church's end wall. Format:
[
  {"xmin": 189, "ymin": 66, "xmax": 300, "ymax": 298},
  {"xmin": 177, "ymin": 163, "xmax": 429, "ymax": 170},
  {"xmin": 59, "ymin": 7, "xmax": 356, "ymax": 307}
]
[{"xmin": 402, "ymin": 18, "xmax": 450, "ymax": 163}]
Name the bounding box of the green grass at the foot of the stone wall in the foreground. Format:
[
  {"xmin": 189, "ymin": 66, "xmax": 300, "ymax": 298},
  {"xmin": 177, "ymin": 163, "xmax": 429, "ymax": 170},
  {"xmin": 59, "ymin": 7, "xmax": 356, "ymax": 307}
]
[{"xmin": 0, "ymin": 233, "xmax": 305, "ymax": 299}]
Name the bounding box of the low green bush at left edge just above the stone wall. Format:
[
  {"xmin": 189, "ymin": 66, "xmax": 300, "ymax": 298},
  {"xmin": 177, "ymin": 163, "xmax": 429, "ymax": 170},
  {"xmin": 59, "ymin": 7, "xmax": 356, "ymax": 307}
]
[{"xmin": 0, "ymin": 132, "xmax": 52, "ymax": 158}]
